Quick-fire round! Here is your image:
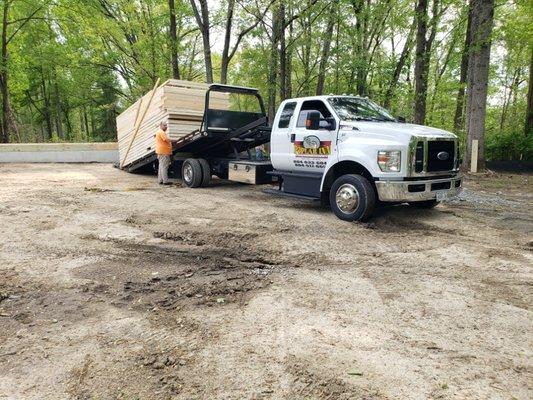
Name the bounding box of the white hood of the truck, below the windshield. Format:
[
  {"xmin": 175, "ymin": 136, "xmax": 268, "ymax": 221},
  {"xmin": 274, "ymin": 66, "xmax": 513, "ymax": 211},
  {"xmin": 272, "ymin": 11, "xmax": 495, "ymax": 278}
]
[{"xmin": 341, "ymin": 121, "xmax": 457, "ymax": 142}]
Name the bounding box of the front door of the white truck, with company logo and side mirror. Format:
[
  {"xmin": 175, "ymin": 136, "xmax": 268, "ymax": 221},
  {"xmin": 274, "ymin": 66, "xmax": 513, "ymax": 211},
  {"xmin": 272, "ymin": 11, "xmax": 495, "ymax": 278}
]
[{"xmin": 290, "ymin": 99, "xmax": 336, "ymax": 173}]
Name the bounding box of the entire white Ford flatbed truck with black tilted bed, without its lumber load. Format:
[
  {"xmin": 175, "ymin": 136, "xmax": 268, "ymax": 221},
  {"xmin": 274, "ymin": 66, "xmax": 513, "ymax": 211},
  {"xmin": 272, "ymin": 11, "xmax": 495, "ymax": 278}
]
[{"xmin": 122, "ymin": 84, "xmax": 462, "ymax": 221}]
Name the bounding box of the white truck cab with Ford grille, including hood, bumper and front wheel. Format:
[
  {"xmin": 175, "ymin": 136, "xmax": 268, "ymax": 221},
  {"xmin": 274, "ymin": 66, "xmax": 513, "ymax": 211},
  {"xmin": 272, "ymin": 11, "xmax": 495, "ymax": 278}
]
[{"xmin": 270, "ymin": 95, "xmax": 461, "ymax": 221}]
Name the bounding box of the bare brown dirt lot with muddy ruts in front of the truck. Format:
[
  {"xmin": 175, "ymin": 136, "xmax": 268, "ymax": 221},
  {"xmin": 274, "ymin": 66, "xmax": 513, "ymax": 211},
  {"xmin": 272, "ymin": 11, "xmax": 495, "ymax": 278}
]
[{"xmin": 0, "ymin": 164, "xmax": 533, "ymax": 400}]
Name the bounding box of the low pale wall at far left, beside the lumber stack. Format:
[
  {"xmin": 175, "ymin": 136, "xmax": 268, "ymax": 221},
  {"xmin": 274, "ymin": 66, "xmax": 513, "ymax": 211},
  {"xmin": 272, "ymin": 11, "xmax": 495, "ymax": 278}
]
[{"xmin": 0, "ymin": 142, "xmax": 118, "ymax": 163}]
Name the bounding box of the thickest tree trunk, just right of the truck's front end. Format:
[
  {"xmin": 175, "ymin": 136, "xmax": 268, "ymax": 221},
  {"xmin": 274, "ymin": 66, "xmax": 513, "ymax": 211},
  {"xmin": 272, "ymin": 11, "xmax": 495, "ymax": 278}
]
[{"xmin": 465, "ymin": 0, "xmax": 494, "ymax": 170}]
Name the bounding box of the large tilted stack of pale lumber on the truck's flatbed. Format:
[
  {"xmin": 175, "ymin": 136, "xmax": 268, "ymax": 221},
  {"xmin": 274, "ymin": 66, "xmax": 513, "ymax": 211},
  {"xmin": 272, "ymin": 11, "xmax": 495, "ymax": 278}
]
[{"xmin": 117, "ymin": 79, "xmax": 229, "ymax": 168}]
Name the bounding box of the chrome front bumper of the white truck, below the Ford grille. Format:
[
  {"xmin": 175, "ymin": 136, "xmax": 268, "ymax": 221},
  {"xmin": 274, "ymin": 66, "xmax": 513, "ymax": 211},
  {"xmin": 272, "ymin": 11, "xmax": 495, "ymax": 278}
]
[{"xmin": 375, "ymin": 175, "xmax": 463, "ymax": 202}]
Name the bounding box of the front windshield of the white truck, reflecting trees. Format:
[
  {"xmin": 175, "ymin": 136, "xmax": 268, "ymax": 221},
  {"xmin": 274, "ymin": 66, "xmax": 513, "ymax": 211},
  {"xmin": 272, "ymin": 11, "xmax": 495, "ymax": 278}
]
[{"xmin": 328, "ymin": 97, "xmax": 396, "ymax": 122}]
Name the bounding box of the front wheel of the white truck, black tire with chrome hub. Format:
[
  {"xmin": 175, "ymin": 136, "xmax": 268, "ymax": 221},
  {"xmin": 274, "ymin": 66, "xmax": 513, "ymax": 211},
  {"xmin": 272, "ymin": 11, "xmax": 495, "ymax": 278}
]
[{"xmin": 329, "ymin": 174, "xmax": 376, "ymax": 221}]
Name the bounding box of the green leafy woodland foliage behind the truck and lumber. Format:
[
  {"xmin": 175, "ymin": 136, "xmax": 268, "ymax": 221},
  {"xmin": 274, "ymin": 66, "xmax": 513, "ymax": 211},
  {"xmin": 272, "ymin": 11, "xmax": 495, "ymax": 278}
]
[{"xmin": 0, "ymin": 0, "xmax": 533, "ymax": 160}]
